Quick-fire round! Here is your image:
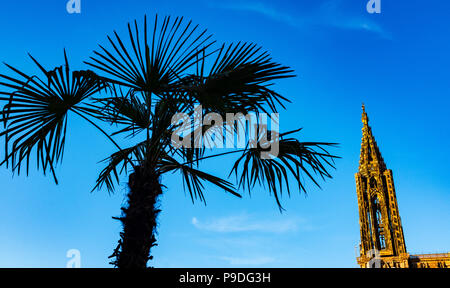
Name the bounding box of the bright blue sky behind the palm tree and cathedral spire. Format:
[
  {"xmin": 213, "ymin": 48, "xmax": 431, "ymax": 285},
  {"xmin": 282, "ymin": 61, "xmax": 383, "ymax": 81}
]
[{"xmin": 0, "ymin": 0, "xmax": 450, "ymax": 267}]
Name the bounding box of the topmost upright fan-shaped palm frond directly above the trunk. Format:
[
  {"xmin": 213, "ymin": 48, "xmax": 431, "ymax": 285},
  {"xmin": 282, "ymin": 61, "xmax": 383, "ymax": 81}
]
[{"xmin": 86, "ymin": 16, "xmax": 213, "ymax": 97}]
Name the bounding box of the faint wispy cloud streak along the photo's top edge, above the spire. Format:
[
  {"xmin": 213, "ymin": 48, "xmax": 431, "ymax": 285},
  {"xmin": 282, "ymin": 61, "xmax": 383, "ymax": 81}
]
[{"xmin": 208, "ymin": 0, "xmax": 391, "ymax": 39}]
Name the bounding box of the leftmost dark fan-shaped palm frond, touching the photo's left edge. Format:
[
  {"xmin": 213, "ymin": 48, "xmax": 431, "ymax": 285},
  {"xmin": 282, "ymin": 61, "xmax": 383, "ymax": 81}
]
[{"xmin": 0, "ymin": 51, "xmax": 107, "ymax": 181}]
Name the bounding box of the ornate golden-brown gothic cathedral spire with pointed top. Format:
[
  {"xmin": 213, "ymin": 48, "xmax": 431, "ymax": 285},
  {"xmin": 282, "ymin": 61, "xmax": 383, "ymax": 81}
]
[{"xmin": 355, "ymin": 104, "xmax": 408, "ymax": 266}]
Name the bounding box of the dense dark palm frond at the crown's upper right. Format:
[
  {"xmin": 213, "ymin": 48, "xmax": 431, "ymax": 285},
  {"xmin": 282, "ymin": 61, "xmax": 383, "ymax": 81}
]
[{"xmin": 184, "ymin": 42, "xmax": 294, "ymax": 115}]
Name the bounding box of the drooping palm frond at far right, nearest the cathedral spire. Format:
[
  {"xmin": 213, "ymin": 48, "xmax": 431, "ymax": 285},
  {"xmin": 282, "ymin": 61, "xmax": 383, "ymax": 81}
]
[{"xmin": 230, "ymin": 130, "xmax": 339, "ymax": 210}]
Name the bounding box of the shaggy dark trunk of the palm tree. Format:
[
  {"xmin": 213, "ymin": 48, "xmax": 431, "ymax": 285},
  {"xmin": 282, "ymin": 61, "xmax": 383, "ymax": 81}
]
[{"xmin": 111, "ymin": 167, "xmax": 162, "ymax": 269}]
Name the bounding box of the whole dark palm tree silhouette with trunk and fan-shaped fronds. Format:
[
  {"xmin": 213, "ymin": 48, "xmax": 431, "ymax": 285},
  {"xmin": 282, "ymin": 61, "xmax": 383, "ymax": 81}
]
[{"xmin": 0, "ymin": 16, "xmax": 336, "ymax": 268}]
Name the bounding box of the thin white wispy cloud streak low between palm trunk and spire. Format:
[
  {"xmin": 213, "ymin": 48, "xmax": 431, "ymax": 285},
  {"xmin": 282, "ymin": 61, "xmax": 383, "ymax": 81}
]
[{"xmin": 191, "ymin": 214, "xmax": 305, "ymax": 233}]
